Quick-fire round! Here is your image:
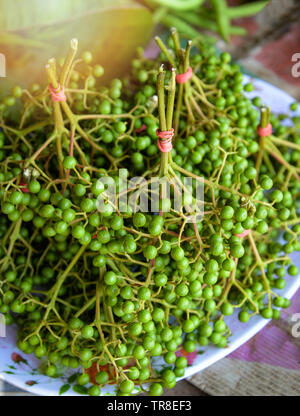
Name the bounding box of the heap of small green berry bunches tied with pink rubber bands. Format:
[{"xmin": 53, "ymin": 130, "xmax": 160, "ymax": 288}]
[{"xmin": 0, "ymin": 31, "xmax": 300, "ymax": 396}]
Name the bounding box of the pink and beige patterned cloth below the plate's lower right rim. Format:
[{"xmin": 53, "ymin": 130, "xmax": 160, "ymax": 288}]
[{"xmin": 189, "ymin": 290, "xmax": 300, "ymax": 396}]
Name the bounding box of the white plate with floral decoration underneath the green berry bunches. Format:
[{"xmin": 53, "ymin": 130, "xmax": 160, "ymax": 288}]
[{"xmin": 0, "ymin": 76, "xmax": 300, "ymax": 396}]
